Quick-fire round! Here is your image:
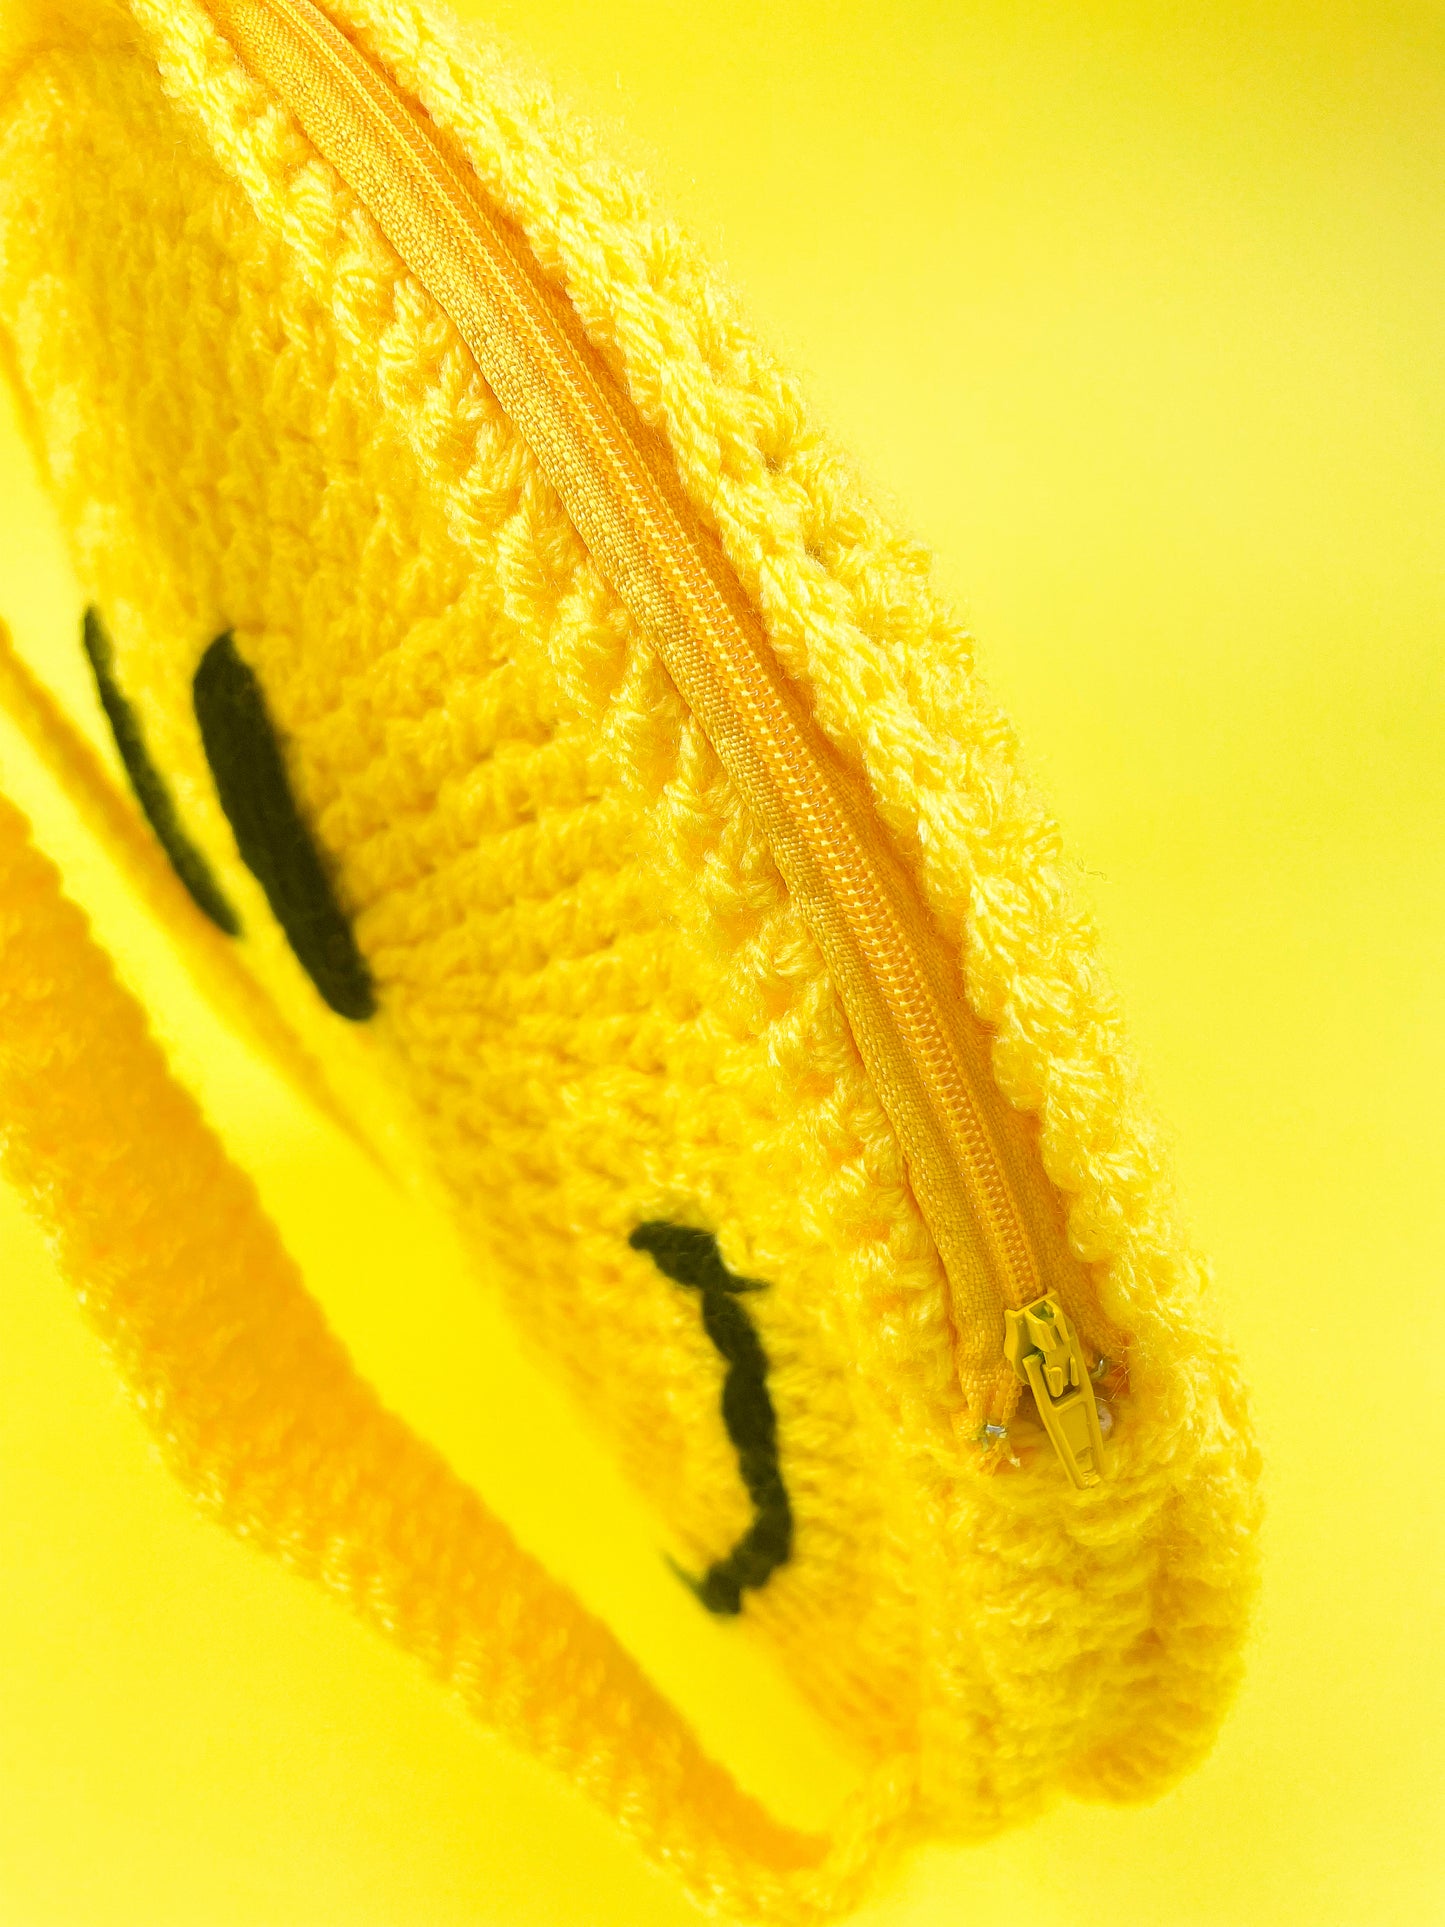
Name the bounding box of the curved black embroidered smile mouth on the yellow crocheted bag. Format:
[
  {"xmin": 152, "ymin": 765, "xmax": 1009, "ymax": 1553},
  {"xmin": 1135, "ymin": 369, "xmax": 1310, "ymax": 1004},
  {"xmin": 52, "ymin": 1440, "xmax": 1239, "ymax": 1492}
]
[{"xmin": 628, "ymin": 1222, "xmax": 792, "ymax": 1613}]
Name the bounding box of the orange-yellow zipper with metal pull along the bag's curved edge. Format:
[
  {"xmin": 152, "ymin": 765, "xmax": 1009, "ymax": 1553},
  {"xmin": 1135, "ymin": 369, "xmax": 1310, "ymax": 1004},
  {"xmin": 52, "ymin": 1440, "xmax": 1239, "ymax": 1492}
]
[{"xmin": 206, "ymin": 0, "xmax": 1119, "ymax": 1484}]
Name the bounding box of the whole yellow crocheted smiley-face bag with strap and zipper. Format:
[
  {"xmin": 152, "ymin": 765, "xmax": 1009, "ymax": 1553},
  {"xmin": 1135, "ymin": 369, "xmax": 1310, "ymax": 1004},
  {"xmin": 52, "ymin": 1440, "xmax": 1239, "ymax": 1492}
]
[{"xmin": 0, "ymin": 0, "xmax": 1256, "ymax": 1921}]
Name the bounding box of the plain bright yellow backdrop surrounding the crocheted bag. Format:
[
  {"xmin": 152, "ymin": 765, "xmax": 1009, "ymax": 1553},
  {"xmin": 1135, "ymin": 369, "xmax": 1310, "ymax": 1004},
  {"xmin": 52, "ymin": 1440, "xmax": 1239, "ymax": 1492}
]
[{"xmin": 0, "ymin": 0, "xmax": 1445, "ymax": 1927}]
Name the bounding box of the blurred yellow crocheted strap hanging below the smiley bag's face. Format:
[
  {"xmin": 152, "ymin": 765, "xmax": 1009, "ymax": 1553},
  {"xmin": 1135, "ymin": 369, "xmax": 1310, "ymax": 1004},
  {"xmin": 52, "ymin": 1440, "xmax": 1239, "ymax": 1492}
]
[{"xmin": 0, "ymin": 759, "xmax": 915, "ymax": 1923}]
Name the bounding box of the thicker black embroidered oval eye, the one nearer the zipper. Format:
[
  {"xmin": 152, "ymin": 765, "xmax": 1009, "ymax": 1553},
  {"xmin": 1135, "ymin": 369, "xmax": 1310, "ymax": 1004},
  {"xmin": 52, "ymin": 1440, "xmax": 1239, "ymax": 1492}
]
[{"xmin": 191, "ymin": 630, "xmax": 376, "ymax": 1019}]
